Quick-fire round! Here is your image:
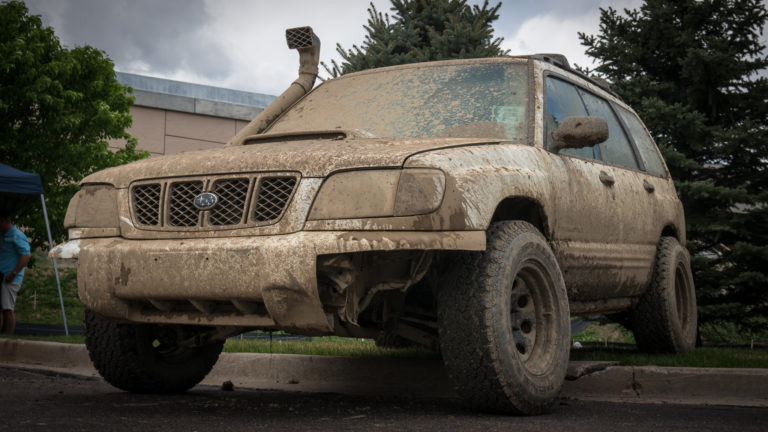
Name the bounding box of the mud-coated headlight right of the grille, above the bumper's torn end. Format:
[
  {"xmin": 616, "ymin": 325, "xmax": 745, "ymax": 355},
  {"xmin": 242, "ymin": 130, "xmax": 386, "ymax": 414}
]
[{"xmin": 309, "ymin": 168, "xmax": 445, "ymax": 220}]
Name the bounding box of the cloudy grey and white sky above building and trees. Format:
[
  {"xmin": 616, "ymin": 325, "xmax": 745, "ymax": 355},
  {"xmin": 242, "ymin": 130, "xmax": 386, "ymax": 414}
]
[{"xmin": 25, "ymin": 0, "xmax": 656, "ymax": 95}]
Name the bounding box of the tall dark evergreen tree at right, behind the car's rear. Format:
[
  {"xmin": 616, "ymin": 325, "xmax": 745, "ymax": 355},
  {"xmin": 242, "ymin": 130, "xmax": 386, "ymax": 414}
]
[{"xmin": 579, "ymin": 0, "xmax": 768, "ymax": 332}]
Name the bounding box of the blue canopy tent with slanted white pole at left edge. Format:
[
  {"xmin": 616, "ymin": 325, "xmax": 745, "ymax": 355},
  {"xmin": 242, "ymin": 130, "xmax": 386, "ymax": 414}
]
[{"xmin": 0, "ymin": 163, "xmax": 69, "ymax": 336}]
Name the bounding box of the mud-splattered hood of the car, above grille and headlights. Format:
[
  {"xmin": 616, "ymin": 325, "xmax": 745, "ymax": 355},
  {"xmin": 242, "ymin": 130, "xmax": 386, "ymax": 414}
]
[{"xmin": 82, "ymin": 138, "xmax": 498, "ymax": 188}]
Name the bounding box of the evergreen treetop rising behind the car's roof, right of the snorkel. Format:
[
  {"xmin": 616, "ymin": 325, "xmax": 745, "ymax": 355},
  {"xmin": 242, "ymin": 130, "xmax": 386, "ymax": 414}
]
[{"xmin": 323, "ymin": 0, "xmax": 506, "ymax": 77}]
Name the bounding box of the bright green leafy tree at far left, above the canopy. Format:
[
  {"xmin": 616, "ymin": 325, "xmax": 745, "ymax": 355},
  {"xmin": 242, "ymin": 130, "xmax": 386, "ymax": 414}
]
[{"xmin": 0, "ymin": 1, "xmax": 148, "ymax": 246}]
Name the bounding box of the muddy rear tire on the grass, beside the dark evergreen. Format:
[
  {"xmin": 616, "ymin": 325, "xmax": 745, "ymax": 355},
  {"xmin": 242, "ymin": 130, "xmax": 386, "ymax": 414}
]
[{"xmin": 631, "ymin": 237, "xmax": 697, "ymax": 353}]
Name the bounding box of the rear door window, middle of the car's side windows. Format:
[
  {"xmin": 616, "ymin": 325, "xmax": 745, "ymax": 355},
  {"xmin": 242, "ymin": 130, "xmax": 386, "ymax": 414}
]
[{"xmin": 579, "ymin": 89, "xmax": 638, "ymax": 169}]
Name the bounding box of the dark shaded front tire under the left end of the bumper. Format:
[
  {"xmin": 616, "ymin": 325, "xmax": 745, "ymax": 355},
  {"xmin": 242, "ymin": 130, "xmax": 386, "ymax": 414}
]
[{"xmin": 85, "ymin": 310, "xmax": 224, "ymax": 393}]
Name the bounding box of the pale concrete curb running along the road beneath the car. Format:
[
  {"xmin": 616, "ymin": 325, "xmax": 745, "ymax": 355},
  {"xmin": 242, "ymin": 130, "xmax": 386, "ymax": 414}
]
[{"xmin": 0, "ymin": 339, "xmax": 768, "ymax": 407}]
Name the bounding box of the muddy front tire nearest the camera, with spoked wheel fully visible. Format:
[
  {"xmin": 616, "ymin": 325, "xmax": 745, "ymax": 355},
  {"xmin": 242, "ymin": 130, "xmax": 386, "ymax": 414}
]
[{"xmin": 438, "ymin": 221, "xmax": 570, "ymax": 415}]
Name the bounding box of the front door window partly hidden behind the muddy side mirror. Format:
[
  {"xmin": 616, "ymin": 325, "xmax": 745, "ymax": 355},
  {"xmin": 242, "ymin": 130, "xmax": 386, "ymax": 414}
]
[{"xmin": 544, "ymin": 77, "xmax": 600, "ymax": 159}]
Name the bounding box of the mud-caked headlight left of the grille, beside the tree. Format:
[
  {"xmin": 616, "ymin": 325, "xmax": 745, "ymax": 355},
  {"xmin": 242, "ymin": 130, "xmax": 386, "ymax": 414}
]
[{"xmin": 64, "ymin": 184, "xmax": 120, "ymax": 239}]
